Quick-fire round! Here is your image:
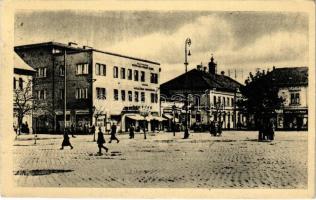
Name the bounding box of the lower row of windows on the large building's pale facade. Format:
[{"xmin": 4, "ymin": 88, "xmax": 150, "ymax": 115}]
[{"xmin": 96, "ymin": 87, "xmax": 158, "ymax": 103}]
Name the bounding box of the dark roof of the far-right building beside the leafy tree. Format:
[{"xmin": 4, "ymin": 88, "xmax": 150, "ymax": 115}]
[{"xmin": 266, "ymin": 67, "xmax": 308, "ymax": 87}]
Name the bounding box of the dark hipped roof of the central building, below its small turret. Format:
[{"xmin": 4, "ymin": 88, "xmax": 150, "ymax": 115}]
[{"xmin": 160, "ymin": 69, "xmax": 241, "ymax": 93}]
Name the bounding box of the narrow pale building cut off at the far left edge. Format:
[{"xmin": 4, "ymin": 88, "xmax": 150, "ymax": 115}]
[{"xmin": 13, "ymin": 55, "xmax": 35, "ymax": 133}]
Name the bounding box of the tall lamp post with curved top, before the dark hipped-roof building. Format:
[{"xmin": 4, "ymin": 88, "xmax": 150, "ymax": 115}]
[{"xmin": 183, "ymin": 38, "xmax": 191, "ymax": 139}]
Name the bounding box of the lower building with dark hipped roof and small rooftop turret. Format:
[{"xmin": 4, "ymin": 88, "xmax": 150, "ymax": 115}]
[{"xmin": 161, "ymin": 57, "xmax": 246, "ymax": 129}]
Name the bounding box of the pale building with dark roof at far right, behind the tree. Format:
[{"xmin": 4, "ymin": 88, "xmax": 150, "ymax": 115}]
[{"xmin": 267, "ymin": 67, "xmax": 308, "ymax": 130}]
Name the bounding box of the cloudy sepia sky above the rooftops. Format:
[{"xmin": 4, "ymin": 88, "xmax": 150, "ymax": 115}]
[{"xmin": 14, "ymin": 10, "xmax": 309, "ymax": 83}]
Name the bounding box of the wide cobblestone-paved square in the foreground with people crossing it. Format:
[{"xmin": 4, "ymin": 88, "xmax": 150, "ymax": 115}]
[{"xmin": 12, "ymin": 131, "xmax": 307, "ymax": 188}]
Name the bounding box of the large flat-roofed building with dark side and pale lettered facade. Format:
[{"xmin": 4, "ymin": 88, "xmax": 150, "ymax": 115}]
[{"xmin": 15, "ymin": 42, "xmax": 162, "ymax": 134}]
